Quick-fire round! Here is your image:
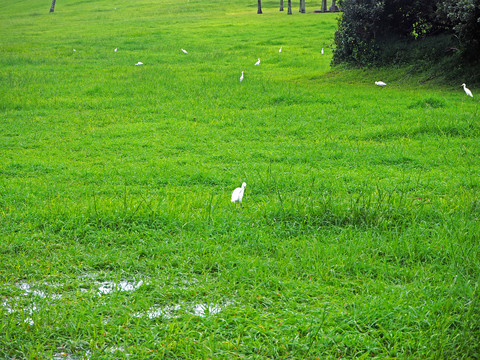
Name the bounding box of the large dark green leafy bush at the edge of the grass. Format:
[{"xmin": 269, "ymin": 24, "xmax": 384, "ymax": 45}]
[{"xmin": 333, "ymin": 0, "xmax": 480, "ymax": 65}]
